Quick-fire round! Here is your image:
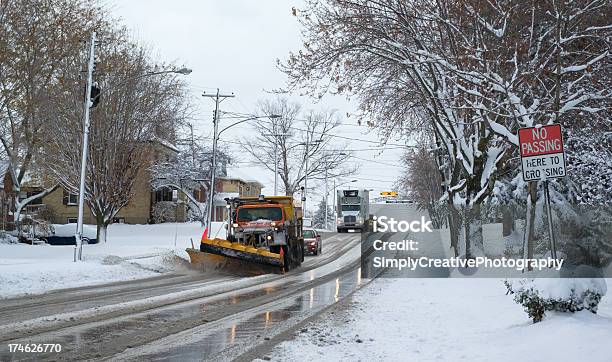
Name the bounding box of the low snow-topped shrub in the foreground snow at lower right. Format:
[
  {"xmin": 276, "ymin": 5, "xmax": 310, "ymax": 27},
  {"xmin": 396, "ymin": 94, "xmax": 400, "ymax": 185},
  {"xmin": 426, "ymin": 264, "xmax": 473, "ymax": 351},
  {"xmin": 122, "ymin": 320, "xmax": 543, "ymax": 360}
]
[{"xmin": 504, "ymin": 278, "xmax": 607, "ymax": 323}]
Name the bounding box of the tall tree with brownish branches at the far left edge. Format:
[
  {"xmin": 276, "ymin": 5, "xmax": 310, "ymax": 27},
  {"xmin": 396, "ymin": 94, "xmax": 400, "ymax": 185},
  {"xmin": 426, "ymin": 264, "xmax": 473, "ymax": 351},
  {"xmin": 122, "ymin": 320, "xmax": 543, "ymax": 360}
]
[{"xmin": 0, "ymin": 0, "xmax": 111, "ymax": 226}]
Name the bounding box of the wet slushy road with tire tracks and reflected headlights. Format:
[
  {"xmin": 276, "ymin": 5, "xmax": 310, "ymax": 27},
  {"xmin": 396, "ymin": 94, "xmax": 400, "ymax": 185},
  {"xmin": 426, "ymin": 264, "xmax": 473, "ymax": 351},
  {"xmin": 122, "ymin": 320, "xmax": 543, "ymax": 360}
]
[{"xmin": 0, "ymin": 230, "xmax": 362, "ymax": 361}]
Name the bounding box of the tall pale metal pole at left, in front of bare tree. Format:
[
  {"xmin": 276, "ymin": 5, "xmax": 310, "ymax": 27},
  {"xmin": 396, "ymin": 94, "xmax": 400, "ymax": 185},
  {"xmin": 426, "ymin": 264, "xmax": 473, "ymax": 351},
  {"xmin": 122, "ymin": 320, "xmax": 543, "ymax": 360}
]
[{"xmin": 74, "ymin": 31, "xmax": 96, "ymax": 262}]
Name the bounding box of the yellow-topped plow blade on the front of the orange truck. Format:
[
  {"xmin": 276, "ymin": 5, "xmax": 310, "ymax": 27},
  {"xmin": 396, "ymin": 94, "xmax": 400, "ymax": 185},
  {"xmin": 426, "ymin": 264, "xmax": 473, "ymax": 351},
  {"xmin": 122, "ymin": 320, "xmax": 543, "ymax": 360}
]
[{"xmin": 187, "ymin": 239, "xmax": 284, "ymax": 275}]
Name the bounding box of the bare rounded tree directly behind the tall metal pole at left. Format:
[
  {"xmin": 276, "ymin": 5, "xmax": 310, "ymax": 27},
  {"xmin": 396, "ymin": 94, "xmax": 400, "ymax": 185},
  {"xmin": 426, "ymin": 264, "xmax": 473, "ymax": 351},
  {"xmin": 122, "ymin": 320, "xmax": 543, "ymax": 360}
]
[{"xmin": 44, "ymin": 35, "xmax": 186, "ymax": 241}]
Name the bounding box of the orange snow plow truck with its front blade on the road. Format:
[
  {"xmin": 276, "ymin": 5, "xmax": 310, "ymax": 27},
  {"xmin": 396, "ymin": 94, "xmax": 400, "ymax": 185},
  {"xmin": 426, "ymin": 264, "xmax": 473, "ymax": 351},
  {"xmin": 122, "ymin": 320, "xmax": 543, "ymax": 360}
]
[{"xmin": 187, "ymin": 195, "xmax": 304, "ymax": 275}]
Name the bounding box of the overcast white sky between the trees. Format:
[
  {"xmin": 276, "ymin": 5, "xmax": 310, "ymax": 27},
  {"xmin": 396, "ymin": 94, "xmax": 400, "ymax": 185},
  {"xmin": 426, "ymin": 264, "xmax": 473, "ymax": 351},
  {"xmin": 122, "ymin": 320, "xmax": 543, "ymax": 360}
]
[{"xmin": 110, "ymin": 0, "xmax": 401, "ymax": 209}]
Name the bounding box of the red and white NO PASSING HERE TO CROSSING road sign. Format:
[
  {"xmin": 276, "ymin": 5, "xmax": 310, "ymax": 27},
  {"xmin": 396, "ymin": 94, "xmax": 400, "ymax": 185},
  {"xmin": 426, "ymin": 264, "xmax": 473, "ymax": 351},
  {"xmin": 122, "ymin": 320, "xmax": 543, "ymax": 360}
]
[{"xmin": 518, "ymin": 124, "xmax": 565, "ymax": 181}]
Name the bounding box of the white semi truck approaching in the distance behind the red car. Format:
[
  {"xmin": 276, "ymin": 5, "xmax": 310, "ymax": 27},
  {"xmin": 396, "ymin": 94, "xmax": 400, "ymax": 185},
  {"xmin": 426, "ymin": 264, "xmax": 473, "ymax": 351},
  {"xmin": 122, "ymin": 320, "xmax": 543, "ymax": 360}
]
[{"xmin": 336, "ymin": 190, "xmax": 370, "ymax": 233}]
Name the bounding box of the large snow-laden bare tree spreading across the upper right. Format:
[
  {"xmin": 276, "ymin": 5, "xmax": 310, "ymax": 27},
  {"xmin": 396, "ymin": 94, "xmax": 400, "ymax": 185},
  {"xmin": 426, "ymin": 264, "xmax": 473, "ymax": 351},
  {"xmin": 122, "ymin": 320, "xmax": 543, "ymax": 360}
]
[{"xmin": 281, "ymin": 0, "xmax": 611, "ymax": 258}]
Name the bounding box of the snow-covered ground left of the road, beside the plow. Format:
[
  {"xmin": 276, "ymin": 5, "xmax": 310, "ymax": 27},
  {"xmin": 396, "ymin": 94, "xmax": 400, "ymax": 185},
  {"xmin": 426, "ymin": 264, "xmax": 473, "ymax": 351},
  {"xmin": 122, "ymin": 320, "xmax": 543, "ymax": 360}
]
[{"xmin": 0, "ymin": 223, "xmax": 224, "ymax": 298}]
